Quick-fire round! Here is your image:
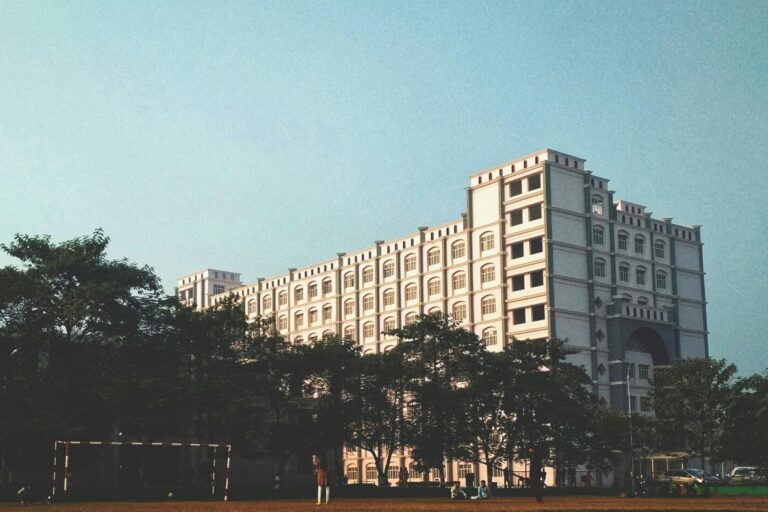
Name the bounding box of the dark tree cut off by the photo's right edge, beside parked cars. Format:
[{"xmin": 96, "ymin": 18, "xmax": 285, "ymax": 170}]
[{"xmin": 723, "ymin": 372, "xmax": 768, "ymax": 467}]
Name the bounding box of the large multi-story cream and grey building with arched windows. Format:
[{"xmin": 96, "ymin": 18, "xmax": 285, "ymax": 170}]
[{"xmin": 178, "ymin": 149, "xmax": 708, "ymax": 483}]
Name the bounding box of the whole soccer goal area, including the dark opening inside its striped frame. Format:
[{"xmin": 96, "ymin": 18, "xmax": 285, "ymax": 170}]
[{"xmin": 50, "ymin": 440, "xmax": 232, "ymax": 501}]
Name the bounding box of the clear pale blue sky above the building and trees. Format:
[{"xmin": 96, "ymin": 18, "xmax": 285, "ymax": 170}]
[{"xmin": 0, "ymin": 0, "xmax": 768, "ymax": 374}]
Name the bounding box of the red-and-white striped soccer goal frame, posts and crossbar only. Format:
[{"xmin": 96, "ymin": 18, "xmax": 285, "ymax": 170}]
[{"xmin": 50, "ymin": 440, "xmax": 232, "ymax": 501}]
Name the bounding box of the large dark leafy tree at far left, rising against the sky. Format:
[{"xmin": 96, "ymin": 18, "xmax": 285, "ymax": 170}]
[{"xmin": 0, "ymin": 230, "xmax": 164, "ymax": 482}]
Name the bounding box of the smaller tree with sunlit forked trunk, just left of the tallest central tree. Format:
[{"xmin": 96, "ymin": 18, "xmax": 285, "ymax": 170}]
[{"xmin": 347, "ymin": 351, "xmax": 408, "ymax": 485}]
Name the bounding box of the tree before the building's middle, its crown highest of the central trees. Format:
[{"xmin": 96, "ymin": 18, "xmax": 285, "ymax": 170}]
[{"xmin": 393, "ymin": 313, "xmax": 485, "ymax": 481}]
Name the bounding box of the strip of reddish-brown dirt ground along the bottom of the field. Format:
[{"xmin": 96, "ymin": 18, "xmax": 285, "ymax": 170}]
[{"xmin": 0, "ymin": 496, "xmax": 768, "ymax": 512}]
